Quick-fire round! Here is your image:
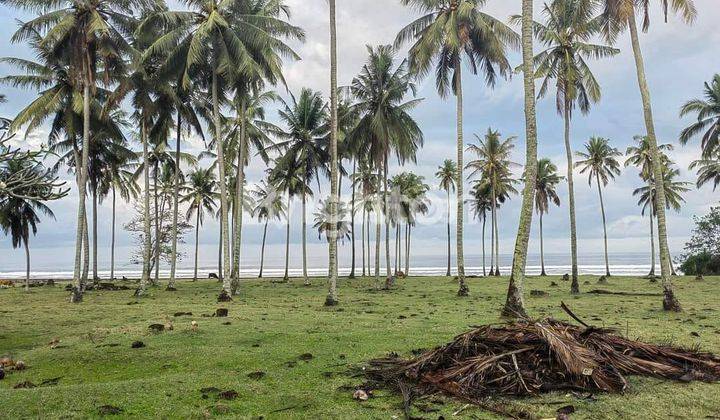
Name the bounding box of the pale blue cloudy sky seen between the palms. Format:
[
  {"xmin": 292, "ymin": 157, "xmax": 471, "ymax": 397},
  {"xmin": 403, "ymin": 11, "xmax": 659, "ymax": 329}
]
[{"xmin": 0, "ymin": 0, "xmax": 720, "ymax": 271}]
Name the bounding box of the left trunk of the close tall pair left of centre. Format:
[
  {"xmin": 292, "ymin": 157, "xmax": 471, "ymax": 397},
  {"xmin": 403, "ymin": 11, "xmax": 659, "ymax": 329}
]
[{"xmin": 212, "ymin": 69, "xmax": 232, "ymax": 294}]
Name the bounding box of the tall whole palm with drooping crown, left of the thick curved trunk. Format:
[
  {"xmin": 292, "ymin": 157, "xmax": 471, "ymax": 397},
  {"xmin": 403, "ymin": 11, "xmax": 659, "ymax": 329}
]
[{"xmin": 395, "ymin": 0, "xmax": 520, "ymax": 296}]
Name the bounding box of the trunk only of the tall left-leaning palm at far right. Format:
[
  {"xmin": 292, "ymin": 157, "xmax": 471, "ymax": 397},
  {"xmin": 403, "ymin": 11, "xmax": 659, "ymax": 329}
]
[{"xmin": 628, "ymin": 8, "xmax": 682, "ymax": 312}]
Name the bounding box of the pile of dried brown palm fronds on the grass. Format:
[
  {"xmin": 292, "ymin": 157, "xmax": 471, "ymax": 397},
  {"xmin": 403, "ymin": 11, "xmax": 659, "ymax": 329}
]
[{"xmin": 366, "ymin": 305, "xmax": 720, "ymax": 414}]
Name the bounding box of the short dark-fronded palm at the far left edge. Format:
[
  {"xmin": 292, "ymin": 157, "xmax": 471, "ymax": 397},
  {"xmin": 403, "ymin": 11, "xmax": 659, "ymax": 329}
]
[{"xmin": 0, "ymin": 160, "xmax": 55, "ymax": 291}]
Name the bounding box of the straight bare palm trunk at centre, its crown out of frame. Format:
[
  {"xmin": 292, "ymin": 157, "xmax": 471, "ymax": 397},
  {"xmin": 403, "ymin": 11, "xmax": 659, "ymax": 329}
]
[{"xmin": 325, "ymin": 0, "xmax": 339, "ymax": 306}]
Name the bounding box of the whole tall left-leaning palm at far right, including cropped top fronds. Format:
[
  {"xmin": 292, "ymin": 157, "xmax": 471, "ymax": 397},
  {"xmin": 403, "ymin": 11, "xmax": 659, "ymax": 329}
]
[{"xmin": 601, "ymin": 0, "xmax": 697, "ymax": 312}]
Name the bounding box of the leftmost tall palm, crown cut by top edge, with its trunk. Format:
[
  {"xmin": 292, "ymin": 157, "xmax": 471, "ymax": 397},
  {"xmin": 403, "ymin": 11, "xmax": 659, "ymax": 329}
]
[{"xmin": 5, "ymin": 0, "xmax": 147, "ymax": 302}]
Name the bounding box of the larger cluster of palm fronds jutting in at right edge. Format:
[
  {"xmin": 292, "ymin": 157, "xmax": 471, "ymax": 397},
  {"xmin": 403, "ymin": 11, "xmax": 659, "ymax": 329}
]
[{"xmin": 680, "ymin": 74, "xmax": 720, "ymax": 159}]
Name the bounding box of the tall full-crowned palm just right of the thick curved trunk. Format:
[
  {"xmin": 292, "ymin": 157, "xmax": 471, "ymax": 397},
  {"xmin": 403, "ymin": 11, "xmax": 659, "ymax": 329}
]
[{"xmin": 534, "ymin": 0, "xmax": 620, "ymax": 293}]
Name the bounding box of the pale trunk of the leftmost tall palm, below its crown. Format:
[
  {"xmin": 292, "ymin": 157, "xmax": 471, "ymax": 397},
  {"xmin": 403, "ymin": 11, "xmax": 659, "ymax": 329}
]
[{"xmin": 70, "ymin": 82, "xmax": 90, "ymax": 303}]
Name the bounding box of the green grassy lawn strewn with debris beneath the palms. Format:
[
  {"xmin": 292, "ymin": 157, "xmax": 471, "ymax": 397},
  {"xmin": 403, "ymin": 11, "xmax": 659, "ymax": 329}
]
[{"xmin": 0, "ymin": 277, "xmax": 720, "ymax": 419}]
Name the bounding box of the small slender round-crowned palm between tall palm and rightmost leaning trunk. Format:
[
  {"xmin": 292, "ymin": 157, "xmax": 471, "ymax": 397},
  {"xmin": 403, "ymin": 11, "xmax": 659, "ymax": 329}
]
[{"xmin": 575, "ymin": 137, "xmax": 622, "ymax": 276}]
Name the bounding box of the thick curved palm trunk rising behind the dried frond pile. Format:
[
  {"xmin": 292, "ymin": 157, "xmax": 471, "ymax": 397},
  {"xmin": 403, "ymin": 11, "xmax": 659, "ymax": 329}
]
[{"xmin": 502, "ymin": 0, "xmax": 537, "ymax": 317}]
